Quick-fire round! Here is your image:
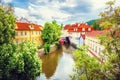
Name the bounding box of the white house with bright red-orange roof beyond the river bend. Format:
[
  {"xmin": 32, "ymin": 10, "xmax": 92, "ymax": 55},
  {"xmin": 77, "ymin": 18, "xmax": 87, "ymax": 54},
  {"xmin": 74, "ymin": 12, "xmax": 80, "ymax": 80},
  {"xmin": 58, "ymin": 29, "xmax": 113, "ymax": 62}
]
[{"xmin": 64, "ymin": 23, "xmax": 93, "ymax": 45}]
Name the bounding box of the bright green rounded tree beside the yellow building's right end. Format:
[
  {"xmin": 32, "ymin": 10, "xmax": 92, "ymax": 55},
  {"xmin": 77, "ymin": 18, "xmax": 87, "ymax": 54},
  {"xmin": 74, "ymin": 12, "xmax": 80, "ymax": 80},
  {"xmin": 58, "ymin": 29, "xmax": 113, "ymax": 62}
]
[{"xmin": 42, "ymin": 21, "xmax": 61, "ymax": 44}]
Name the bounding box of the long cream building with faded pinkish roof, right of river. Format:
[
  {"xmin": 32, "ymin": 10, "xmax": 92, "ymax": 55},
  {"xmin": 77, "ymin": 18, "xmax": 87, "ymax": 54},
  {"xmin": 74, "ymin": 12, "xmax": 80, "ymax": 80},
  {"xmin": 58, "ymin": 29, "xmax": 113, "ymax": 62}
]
[{"xmin": 85, "ymin": 31, "xmax": 105, "ymax": 59}]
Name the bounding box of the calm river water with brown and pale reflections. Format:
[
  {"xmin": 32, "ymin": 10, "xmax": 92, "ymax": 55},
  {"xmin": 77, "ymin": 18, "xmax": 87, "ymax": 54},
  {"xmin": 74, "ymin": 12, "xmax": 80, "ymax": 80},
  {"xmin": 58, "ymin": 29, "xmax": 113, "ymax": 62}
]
[{"xmin": 36, "ymin": 46, "xmax": 74, "ymax": 80}]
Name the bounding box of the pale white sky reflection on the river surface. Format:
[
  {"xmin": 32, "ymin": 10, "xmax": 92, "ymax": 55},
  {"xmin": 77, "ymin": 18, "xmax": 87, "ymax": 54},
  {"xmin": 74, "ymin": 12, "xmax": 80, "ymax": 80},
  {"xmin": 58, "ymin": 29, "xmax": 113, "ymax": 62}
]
[{"xmin": 50, "ymin": 52, "xmax": 74, "ymax": 80}]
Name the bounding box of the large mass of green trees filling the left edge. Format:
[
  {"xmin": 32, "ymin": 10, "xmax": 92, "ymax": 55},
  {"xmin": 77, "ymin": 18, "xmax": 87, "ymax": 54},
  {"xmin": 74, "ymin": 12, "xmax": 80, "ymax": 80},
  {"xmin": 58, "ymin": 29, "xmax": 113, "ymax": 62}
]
[{"xmin": 0, "ymin": 6, "xmax": 41, "ymax": 80}]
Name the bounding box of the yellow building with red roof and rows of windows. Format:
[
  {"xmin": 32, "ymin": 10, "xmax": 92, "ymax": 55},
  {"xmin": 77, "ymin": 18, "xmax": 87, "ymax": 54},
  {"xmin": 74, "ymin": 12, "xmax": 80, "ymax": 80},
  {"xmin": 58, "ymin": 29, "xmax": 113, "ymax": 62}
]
[{"xmin": 14, "ymin": 22, "xmax": 42, "ymax": 45}]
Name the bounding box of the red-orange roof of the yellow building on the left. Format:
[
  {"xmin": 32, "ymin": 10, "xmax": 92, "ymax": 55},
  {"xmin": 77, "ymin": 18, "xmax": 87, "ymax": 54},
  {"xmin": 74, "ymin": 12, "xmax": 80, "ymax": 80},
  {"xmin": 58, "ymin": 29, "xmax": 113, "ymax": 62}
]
[{"xmin": 15, "ymin": 22, "xmax": 42, "ymax": 31}]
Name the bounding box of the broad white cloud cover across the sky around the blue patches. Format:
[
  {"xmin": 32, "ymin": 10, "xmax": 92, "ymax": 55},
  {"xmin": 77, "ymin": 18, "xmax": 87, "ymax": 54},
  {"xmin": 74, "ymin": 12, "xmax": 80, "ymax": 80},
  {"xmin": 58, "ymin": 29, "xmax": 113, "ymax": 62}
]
[{"xmin": 13, "ymin": 0, "xmax": 120, "ymax": 25}]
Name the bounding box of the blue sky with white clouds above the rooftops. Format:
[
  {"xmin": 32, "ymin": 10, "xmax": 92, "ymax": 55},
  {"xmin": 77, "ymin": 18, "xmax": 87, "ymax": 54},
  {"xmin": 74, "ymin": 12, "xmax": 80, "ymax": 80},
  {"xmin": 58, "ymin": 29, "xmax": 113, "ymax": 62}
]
[{"xmin": 2, "ymin": 0, "xmax": 120, "ymax": 25}]
